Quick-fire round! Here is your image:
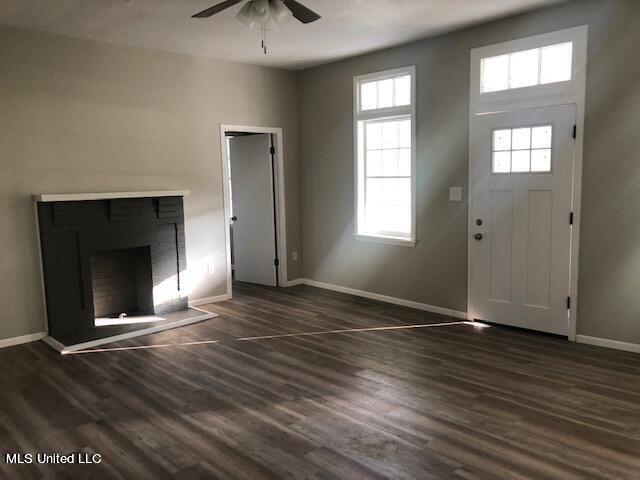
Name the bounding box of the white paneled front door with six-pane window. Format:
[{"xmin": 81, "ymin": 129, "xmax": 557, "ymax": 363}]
[{"xmin": 469, "ymin": 105, "xmax": 576, "ymax": 335}]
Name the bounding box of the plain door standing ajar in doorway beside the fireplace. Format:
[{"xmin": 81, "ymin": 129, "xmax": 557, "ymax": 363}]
[{"xmin": 229, "ymin": 134, "xmax": 277, "ymax": 286}]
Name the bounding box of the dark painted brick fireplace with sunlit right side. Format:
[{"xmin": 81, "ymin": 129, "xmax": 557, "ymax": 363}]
[{"xmin": 37, "ymin": 195, "xmax": 188, "ymax": 343}]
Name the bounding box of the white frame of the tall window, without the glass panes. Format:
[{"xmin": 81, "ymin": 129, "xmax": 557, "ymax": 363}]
[{"xmin": 353, "ymin": 65, "xmax": 416, "ymax": 247}]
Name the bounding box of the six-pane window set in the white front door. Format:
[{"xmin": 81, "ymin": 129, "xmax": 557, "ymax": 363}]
[{"xmin": 492, "ymin": 125, "xmax": 553, "ymax": 173}]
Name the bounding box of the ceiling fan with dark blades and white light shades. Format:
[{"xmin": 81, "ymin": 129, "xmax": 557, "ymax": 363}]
[{"xmin": 192, "ymin": 0, "xmax": 321, "ymax": 55}]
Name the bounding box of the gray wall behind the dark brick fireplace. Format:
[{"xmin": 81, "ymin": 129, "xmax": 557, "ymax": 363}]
[{"xmin": 0, "ymin": 27, "xmax": 300, "ymax": 339}]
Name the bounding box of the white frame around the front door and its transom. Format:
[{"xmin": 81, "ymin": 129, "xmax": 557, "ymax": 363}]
[{"xmin": 467, "ymin": 25, "xmax": 588, "ymax": 341}]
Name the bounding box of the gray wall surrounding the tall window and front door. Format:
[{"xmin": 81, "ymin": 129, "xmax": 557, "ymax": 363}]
[{"xmin": 298, "ymin": 0, "xmax": 640, "ymax": 343}]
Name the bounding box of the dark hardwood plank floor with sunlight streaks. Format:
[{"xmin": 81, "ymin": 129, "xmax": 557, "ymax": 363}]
[{"xmin": 0, "ymin": 284, "xmax": 640, "ymax": 480}]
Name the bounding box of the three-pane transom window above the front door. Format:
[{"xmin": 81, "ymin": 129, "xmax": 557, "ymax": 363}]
[{"xmin": 480, "ymin": 42, "xmax": 573, "ymax": 93}]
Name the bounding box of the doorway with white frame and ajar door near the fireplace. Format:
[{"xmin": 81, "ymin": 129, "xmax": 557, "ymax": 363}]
[{"xmin": 221, "ymin": 125, "xmax": 287, "ymax": 297}]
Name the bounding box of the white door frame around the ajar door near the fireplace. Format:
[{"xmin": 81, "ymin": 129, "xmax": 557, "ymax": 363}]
[{"xmin": 220, "ymin": 124, "xmax": 287, "ymax": 298}]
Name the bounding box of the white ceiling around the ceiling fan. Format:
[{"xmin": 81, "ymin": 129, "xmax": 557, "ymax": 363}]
[{"xmin": 0, "ymin": 0, "xmax": 561, "ymax": 69}]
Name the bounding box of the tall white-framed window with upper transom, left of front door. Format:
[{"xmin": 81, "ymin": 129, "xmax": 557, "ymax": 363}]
[{"xmin": 354, "ymin": 67, "xmax": 415, "ymax": 244}]
